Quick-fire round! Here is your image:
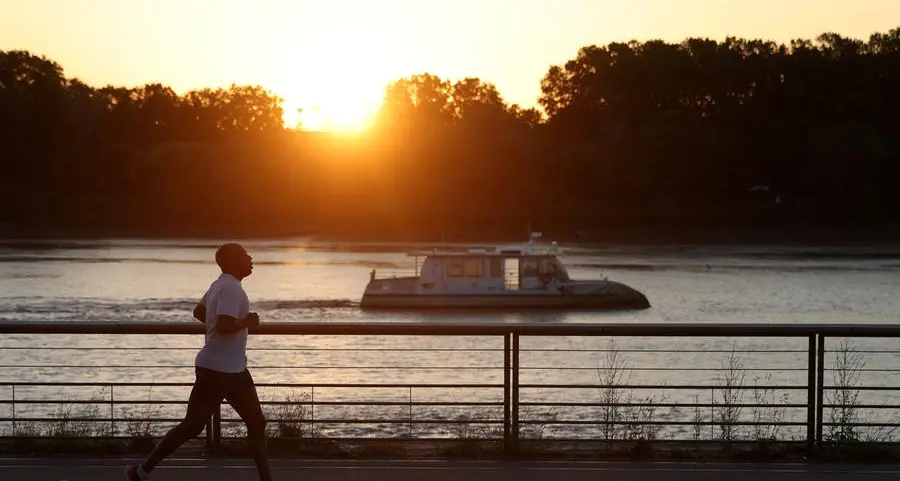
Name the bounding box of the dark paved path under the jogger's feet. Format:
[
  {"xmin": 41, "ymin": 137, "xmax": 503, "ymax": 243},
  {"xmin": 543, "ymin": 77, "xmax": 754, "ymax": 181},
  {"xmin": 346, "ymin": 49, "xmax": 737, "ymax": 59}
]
[{"xmin": 0, "ymin": 458, "xmax": 900, "ymax": 481}]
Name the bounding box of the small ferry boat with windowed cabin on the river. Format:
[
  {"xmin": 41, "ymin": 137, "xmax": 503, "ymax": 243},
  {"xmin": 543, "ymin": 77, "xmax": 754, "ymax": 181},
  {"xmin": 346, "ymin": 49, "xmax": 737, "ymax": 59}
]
[{"xmin": 360, "ymin": 233, "xmax": 650, "ymax": 310}]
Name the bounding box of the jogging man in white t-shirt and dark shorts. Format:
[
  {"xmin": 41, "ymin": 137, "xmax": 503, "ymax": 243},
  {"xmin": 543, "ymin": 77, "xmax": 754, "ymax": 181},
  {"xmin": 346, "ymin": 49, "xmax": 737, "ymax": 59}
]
[{"xmin": 125, "ymin": 243, "xmax": 272, "ymax": 481}]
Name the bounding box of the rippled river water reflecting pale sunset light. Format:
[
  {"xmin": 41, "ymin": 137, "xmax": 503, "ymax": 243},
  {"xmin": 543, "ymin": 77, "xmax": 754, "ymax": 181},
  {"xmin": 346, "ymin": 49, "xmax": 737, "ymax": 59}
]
[{"xmin": 0, "ymin": 239, "xmax": 900, "ymax": 435}]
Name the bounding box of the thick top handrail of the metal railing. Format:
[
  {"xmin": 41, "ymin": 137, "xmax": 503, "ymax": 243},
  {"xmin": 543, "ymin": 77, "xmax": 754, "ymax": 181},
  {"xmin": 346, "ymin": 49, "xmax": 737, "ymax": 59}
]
[{"xmin": 0, "ymin": 321, "xmax": 900, "ymax": 338}]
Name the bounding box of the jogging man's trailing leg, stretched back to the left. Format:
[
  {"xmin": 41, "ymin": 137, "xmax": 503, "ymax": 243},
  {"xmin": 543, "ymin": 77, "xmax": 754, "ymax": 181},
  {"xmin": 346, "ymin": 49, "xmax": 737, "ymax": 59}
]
[{"xmin": 129, "ymin": 370, "xmax": 224, "ymax": 479}]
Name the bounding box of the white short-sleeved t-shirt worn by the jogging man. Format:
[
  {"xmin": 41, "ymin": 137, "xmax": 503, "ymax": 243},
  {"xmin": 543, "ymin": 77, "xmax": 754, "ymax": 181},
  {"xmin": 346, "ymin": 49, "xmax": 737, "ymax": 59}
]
[{"xmin": 194, "ymin": 274, "xmax": 250, "ymax": 373}]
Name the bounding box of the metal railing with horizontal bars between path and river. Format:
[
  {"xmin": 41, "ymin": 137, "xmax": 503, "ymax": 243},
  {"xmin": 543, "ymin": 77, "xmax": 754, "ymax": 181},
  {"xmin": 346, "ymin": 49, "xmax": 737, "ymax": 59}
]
[{"xmin": 0, "ymin": 322, "xmax": 900, "ymax": 454}]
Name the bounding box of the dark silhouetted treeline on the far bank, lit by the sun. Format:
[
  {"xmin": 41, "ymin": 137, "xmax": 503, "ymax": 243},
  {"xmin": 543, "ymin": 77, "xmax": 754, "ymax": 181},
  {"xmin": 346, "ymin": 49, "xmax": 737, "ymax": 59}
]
[{"xmin": 0, "ymin": 29, "xmax": 900, "ymax": 238}]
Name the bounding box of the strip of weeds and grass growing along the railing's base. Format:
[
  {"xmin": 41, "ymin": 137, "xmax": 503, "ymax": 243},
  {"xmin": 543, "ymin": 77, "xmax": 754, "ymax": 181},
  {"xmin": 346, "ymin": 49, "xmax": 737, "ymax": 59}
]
[{"xmin": 0, "ymin": 341, "xmax": 900, "ymax": 461}]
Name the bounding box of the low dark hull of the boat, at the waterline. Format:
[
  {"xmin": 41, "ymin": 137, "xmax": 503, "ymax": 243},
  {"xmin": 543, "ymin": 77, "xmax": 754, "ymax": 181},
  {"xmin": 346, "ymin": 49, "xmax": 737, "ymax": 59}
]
[{"xmin": 360, "ymin": 292, "xmax": 650, "ymax": 310}]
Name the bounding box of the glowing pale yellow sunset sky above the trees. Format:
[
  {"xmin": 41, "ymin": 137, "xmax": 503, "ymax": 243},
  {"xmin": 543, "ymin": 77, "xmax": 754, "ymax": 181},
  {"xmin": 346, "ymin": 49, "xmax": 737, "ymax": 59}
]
[{"xmin": 0, "ymin": 0, "xmax": 900, "ymax": 130}]
